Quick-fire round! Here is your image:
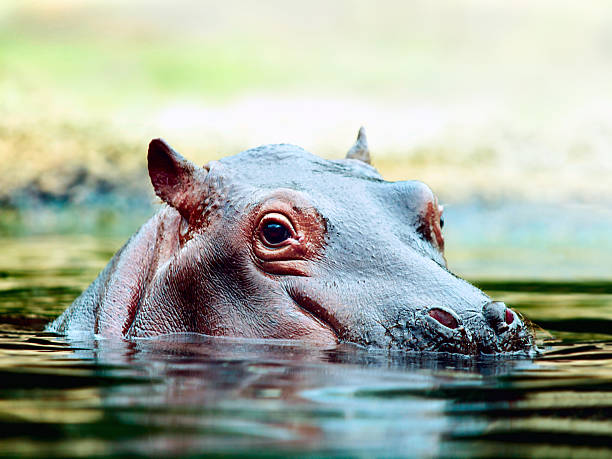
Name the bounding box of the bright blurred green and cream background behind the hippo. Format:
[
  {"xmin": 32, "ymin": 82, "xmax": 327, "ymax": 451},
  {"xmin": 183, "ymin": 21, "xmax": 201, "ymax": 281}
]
[{"xmin": 0, "ymin": 0, "xmax": 612, "ymax": 278}]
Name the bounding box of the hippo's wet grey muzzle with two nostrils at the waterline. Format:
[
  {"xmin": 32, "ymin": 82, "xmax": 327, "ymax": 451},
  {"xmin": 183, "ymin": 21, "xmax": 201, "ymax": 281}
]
[{"xmin": 290, "ymin": 255, "xmax": 535, "ymax": 355}]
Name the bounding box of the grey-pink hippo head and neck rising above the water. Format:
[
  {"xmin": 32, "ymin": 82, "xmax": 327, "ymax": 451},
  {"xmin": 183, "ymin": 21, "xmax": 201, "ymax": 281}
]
[{"xmin": 47, "ymin": 128, "xmax": 536, "ymax": 355}]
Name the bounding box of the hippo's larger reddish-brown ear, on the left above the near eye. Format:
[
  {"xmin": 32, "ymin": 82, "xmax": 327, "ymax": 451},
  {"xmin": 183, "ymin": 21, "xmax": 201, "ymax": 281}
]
[{"xmin": 148, "ymin": 139, "xmax": 208, "ymax": 221}]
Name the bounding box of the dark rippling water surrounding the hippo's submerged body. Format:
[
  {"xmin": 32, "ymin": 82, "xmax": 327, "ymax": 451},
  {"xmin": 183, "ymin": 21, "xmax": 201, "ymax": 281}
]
[{"xmin": 0, "ymin": 235, "xmax": 612, "ymax": 457}]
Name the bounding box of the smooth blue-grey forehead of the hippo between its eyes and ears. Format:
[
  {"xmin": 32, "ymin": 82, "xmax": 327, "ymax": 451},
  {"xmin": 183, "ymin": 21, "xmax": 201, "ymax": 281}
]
[{"xmin": 210, "ymin": 144, "xmax": 446, "ymax": 266}]
